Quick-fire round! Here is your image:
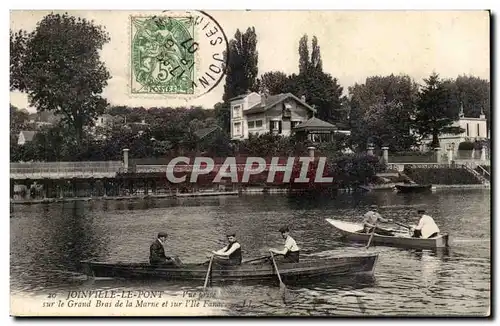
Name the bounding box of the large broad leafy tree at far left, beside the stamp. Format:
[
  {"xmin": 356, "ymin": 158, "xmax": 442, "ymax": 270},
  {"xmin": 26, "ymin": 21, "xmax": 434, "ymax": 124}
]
[{"xmin": 11, "ymin": 13, "xmax": 110, "ymax": 143}]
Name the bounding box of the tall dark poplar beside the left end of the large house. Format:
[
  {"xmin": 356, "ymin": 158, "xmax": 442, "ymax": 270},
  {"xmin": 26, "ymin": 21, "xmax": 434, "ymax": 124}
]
[{"xmin": 223, "ymin": 27, "xmax": 259, "ymax": 102}]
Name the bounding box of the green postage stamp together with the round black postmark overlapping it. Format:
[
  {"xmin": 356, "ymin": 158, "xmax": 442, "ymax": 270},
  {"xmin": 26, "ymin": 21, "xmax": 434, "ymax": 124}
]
[{"xmin": 130, "ymin": 11, "xmax": 229, "ymax": 99}]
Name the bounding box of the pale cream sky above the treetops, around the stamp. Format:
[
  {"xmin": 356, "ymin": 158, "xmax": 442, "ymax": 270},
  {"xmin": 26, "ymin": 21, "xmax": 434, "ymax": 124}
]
[{"xmin": 10, "ymin": 10, "xmax": 490, "ymax": 111}]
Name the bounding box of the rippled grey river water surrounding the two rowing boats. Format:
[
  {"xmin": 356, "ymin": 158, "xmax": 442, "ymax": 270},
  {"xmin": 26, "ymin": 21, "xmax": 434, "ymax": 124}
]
[{"xmin": 10, "ymin": 190, "xmax": 491, "ymax": 316}]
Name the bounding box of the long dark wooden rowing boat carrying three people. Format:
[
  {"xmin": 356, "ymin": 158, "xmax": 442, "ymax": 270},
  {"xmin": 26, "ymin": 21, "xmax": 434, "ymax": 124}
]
[{"xmin": 81, "ymin": 253, "xmax": 378, "ymax": 281}]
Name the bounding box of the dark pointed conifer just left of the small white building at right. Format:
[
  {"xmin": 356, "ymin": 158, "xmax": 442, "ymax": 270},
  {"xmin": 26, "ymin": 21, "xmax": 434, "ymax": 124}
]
[{"xmin": 415, "ymin": 73, "xmax": 463, "ymax": 148}]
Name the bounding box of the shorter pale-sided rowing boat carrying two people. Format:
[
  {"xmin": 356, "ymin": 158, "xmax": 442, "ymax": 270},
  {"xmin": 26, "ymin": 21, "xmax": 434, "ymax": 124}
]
[{"xmin": 326, "ymin": 218, "xmax": 448, "ymax": 249}]
